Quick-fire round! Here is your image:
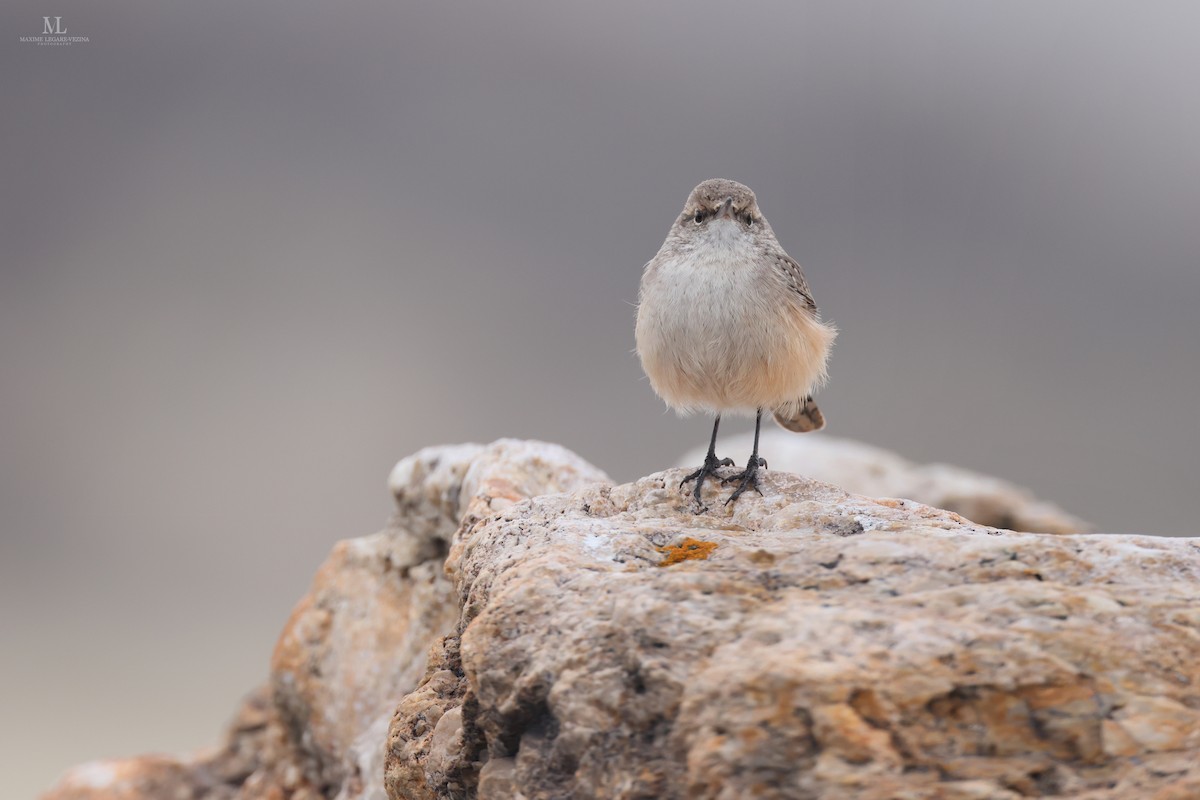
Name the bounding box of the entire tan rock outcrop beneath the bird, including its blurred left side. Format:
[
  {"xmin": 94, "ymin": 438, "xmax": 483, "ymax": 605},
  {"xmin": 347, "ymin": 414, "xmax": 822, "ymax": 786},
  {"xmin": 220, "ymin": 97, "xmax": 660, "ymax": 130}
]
[{"xmin": 47, "ymin": 441, "xmax": 1200, "ymax": 800}]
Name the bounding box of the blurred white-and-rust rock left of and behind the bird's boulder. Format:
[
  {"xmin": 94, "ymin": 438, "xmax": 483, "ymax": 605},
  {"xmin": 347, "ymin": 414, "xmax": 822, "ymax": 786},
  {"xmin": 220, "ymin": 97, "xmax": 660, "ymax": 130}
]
[{"xmin": 43, "ymin": 440, "xmax": 607, "ymax": 800}]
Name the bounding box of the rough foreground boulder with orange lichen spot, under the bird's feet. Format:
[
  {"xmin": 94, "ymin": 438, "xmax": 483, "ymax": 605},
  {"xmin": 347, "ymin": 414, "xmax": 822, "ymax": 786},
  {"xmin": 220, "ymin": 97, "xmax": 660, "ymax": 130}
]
[{"xmin": 385, "ymin": 470, "xmax": 1200, "ymax": 800}]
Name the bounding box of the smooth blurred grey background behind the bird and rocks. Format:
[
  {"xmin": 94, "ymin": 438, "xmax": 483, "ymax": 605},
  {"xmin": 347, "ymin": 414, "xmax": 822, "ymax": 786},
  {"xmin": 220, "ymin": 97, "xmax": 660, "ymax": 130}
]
[{"xmin": 0, "ymin": 0, "xmax": 1200, "ymax": 796}]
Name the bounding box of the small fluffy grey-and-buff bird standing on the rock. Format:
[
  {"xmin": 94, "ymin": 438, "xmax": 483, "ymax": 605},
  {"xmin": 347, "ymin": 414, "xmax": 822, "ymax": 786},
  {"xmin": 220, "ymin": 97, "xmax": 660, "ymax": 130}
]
[{"xmin": 637, "ymin": 180, "xmax": 836, "ymax": 509}]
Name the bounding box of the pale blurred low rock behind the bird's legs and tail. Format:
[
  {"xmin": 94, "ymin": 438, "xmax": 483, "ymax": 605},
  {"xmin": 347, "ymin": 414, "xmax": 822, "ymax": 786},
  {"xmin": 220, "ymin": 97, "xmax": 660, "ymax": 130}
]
[{"xmin": 679, "ymin": 429, "xmax": 1094, "ymax": 534}]
